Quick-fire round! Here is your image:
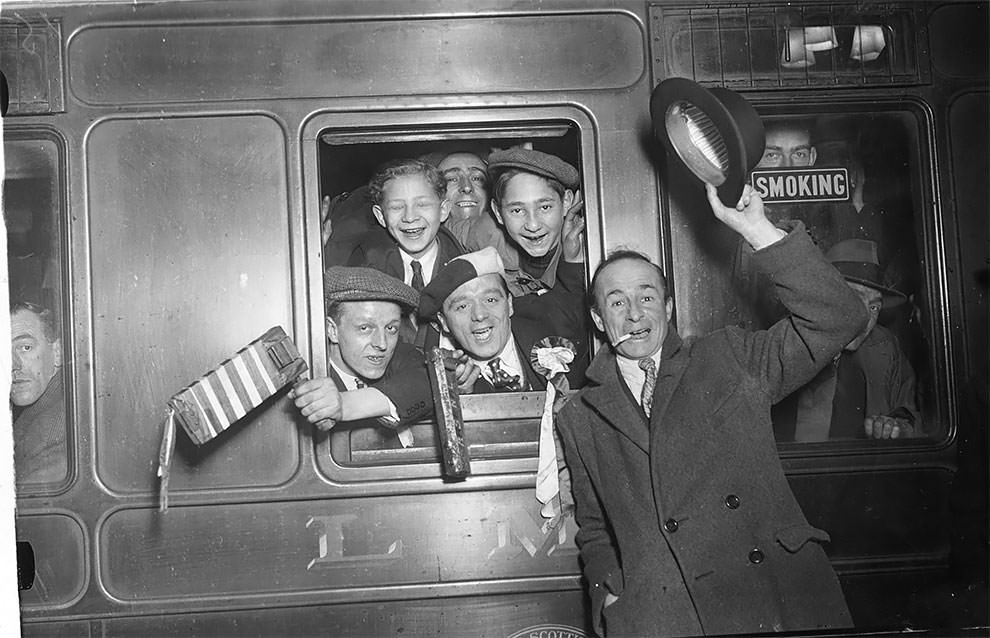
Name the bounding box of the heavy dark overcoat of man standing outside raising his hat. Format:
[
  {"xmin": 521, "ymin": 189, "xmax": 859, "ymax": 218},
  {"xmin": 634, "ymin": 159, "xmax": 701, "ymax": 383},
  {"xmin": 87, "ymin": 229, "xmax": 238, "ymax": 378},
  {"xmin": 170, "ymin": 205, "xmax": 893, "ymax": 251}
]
[{"xmin": 557, "ymin": 224, "xmax": 866, "ymax": 636}]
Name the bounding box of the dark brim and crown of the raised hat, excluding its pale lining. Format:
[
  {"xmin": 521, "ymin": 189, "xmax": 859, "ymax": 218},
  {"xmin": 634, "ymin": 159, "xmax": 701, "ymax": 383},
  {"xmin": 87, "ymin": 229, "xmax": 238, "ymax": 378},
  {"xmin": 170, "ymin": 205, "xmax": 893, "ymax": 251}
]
[{"xmin": 650, "ymin": 78, "xmax": 764, "ymax": 206}]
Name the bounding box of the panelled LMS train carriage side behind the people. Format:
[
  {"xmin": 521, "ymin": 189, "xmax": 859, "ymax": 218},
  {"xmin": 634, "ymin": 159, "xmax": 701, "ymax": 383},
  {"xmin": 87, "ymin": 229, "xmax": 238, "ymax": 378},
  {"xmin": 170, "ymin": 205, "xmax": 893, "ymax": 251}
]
[{"xmin": 0, "ymin": 0, "xmax": 990, "ymax": 638}]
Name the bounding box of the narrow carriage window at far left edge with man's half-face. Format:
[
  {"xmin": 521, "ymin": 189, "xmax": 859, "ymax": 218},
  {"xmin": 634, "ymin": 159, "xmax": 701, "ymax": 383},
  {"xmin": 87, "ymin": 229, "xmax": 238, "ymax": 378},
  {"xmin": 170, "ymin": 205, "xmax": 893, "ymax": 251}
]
[{"xmin": 3, "ymin": 134, "xmax": 70, "ymax": 491}]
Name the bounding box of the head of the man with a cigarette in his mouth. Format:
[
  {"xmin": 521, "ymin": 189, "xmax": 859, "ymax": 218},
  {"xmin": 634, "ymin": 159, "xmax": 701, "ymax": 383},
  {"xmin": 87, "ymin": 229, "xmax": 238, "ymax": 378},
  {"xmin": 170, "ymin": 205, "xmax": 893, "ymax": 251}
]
[{"xmin": 591, "ymin": 259, "xmax": 673, "ymax": 359}]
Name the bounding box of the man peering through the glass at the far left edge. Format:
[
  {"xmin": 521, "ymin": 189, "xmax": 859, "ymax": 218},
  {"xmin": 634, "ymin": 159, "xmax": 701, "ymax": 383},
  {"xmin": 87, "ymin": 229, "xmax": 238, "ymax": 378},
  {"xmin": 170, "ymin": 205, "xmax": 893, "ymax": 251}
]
[{"xmin": 10, "ymin": 301, "xmax": 68, "ymax": 486}]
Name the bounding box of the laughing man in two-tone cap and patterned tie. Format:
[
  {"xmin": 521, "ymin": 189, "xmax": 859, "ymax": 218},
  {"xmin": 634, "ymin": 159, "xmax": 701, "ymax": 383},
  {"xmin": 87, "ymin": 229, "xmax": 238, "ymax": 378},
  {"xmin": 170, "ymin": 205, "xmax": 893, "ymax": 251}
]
[{"xmin": 419, "ymin": 247, "xmax": 573, "ymax": 394}]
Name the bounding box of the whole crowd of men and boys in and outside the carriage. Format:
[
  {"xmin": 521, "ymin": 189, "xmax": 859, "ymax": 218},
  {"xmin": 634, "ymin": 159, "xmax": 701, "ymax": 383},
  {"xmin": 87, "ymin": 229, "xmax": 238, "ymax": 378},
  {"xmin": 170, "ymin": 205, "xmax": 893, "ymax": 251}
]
[{"xmin": 10, "ymin": 122, "xmax": 923, "ymax": 636}]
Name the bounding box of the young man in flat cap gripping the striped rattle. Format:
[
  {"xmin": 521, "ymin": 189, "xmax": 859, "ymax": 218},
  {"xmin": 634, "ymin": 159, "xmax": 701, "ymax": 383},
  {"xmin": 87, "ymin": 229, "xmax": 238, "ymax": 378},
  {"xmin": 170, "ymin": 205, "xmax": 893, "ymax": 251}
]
[{"xmin": 293, "ymin": 266, "xmax": 433, "ymax": 445}]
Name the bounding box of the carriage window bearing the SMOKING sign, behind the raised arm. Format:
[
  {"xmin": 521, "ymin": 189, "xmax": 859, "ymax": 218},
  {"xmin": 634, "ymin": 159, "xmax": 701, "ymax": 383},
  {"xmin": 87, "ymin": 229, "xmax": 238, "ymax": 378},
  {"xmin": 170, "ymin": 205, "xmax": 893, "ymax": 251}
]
[{"xmin": 675, "ymin": 103, "xmax": 951, "ymax": 451}]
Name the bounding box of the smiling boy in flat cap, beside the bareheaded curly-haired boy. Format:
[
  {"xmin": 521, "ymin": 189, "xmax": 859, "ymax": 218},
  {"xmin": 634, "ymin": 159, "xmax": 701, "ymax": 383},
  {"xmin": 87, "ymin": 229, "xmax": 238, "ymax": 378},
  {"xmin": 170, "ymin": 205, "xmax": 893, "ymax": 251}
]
[{"xmin": 488, "ymin": 147, "xmax": 590, "ymax": 387}]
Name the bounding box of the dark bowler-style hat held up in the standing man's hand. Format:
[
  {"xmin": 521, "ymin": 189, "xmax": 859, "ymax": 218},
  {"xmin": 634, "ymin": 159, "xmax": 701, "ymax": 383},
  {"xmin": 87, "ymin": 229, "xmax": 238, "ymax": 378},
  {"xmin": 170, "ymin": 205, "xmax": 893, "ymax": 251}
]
[{"xmin": 650, "ymin": 78, "xmax": 766, "ymax": 206}]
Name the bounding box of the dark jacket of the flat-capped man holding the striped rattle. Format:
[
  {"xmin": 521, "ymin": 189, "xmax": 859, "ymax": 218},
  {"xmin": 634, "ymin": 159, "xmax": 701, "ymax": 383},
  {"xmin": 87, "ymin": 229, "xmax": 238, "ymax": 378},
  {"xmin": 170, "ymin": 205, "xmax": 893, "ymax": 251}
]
[{"xmin": 330, "ymin": 341, "xmax": 433, "ymax": 428}]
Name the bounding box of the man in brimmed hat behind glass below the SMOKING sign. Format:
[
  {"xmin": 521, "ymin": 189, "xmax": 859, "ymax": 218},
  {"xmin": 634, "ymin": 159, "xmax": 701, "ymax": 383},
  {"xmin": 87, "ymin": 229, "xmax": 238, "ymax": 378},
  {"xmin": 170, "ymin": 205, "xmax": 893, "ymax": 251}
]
[{"xmin": 774, "ymin": 239, "xmax": 924, "ymax": 443}]
